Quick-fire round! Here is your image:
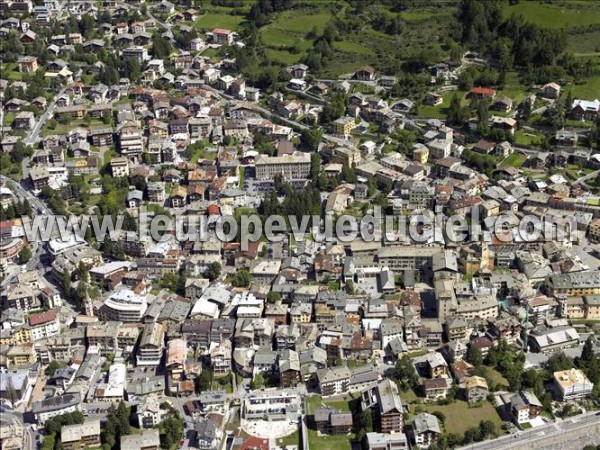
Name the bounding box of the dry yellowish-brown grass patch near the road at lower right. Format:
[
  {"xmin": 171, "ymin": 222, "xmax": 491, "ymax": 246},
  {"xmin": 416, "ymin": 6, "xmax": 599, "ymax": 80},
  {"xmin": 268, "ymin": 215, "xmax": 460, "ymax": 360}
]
[{"xmin": 422, "ymin": 400, "xmax": 502, "ymax": 434}]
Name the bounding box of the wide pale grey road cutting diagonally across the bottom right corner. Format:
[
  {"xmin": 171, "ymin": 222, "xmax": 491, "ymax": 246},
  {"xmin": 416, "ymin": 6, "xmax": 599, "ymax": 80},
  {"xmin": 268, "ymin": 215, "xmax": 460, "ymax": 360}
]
[{"xmin": 454, "ymin": 411, "xmax": 600, "ymax": 450}]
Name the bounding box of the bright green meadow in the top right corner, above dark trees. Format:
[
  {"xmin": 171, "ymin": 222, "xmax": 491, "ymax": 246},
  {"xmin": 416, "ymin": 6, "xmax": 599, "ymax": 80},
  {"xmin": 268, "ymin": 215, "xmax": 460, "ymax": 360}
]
[{"xmin": 503, "ymin": 0, "xmax": 600, "ymax": 28}]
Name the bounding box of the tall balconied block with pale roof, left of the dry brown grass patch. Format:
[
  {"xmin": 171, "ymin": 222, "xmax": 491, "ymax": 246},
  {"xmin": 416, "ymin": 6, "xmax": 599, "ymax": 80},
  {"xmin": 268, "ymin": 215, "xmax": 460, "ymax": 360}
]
[{"xmin": 361, "ymin": 378, "xmax": 403, "ymax": 433}]
